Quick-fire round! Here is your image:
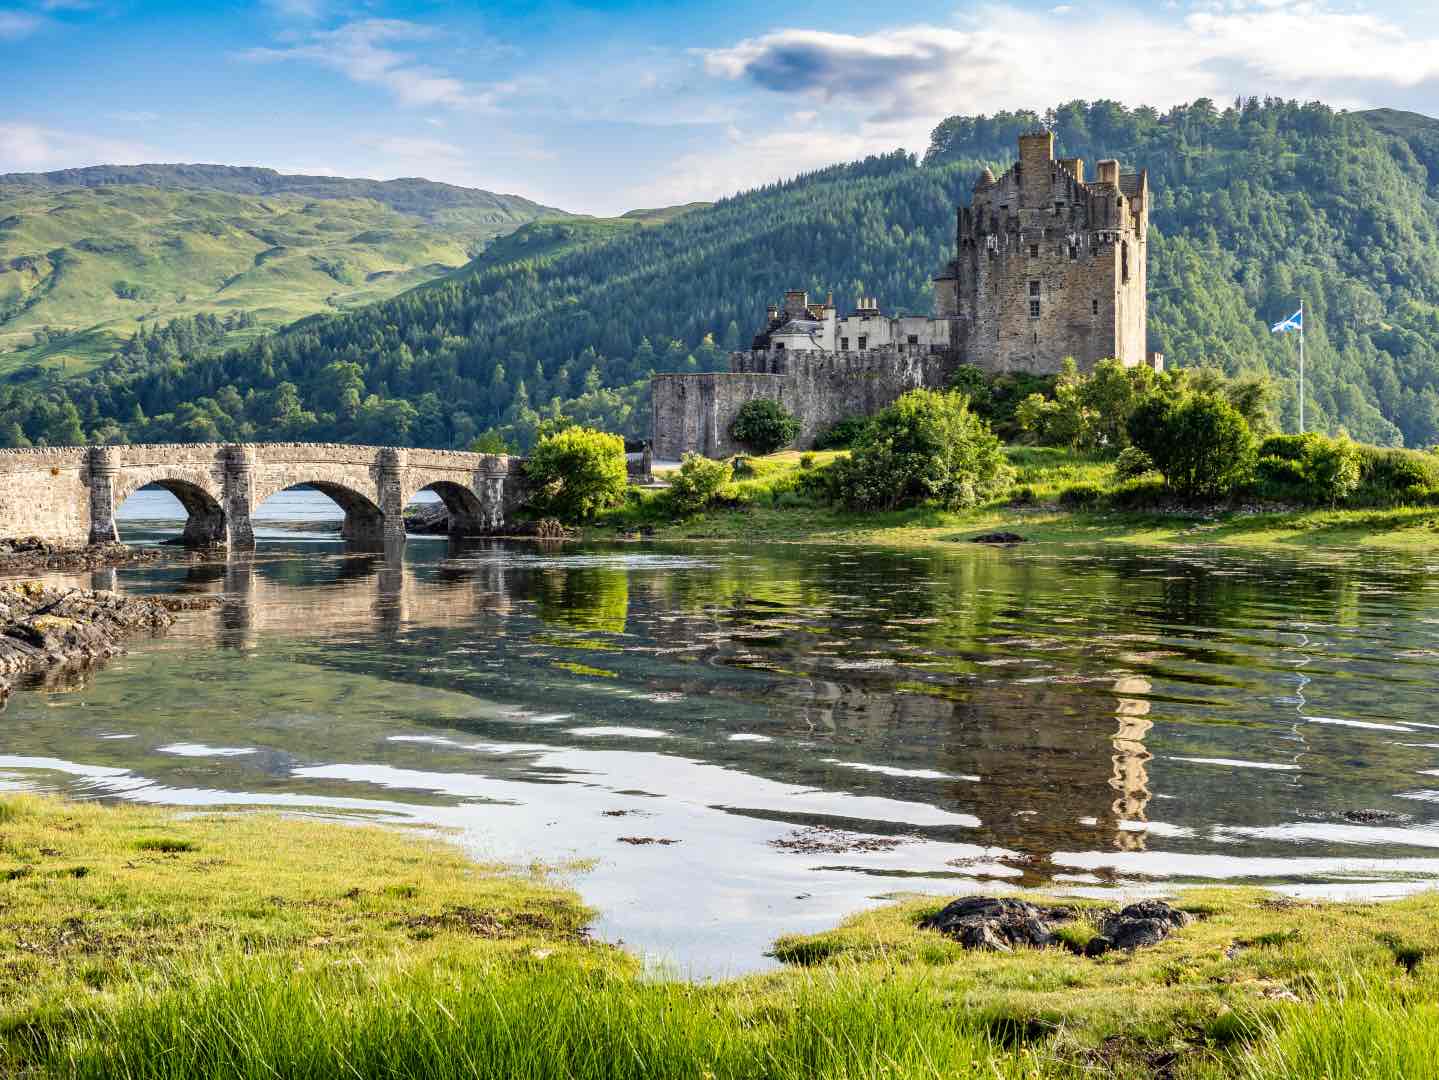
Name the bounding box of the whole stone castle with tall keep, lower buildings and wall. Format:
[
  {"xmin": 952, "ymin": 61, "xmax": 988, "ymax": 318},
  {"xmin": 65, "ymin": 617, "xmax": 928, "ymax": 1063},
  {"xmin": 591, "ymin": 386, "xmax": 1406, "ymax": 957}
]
[{"xmin": 653, "ymin": 132, "xmax": 1163, "ymax": 460}]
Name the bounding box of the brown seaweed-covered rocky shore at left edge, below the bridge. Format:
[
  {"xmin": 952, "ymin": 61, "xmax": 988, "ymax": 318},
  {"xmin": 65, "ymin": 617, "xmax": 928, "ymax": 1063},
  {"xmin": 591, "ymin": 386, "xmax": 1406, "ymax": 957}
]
[{"xmin": 0, "ymin": 581, "xmax": 176, "ymax": 703}]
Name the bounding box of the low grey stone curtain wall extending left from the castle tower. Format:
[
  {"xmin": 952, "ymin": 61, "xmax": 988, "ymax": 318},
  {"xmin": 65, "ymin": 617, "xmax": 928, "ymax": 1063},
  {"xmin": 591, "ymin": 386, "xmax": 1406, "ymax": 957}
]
[{"xmin": 653, "ymin": 348, "xmax": 958, "ymax": 462}]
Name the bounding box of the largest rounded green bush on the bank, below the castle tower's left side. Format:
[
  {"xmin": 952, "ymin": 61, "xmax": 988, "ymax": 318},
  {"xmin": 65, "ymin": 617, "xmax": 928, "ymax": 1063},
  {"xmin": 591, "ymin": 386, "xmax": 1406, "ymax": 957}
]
[{"xmin": 825, "ymin": 390, "xmax": 1013, "ymax": 511}]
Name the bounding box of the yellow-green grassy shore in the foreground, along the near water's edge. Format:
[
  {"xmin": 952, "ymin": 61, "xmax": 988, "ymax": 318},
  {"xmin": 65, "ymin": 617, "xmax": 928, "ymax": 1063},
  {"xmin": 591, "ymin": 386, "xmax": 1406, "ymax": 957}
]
[{"xmin": 8, "ymin": 797, "xmax": 1439, "ymax": 1080}]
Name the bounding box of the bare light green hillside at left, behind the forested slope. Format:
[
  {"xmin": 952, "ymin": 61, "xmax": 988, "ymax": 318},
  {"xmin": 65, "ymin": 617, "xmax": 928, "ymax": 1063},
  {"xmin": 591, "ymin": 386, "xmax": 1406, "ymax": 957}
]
[{"xmin": 0, "ymin": 165, "xmax": 558, "ymax": 371}]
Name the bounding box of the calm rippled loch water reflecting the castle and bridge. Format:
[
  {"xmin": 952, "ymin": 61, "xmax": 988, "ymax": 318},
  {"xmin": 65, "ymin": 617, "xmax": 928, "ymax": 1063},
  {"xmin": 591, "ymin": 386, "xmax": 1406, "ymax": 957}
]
[{"xmin": 8, "ymin": 492, "xmax": 1439, "ymax": 975}]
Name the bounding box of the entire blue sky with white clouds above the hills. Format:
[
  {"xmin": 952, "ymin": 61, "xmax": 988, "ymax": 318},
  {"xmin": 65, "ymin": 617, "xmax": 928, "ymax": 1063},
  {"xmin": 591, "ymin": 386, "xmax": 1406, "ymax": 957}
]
[{"xmin": 0, "ymin": 0, "xmax": 1439, "ymax": 213}]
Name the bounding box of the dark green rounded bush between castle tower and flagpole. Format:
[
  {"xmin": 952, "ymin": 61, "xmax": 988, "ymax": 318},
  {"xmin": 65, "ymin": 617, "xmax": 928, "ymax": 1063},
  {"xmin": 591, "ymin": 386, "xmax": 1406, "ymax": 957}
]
[{"xmin": 1128, "ymin": 394, "xmax": 1255, "ymax": 499}]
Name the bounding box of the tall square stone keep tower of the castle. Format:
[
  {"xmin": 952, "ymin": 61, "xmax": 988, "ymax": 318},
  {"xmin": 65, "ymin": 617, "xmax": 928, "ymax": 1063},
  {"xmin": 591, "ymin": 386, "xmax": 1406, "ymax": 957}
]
[{"xmin": 934, "ymin": 132, "xmax": 1150, "ymax": 374}]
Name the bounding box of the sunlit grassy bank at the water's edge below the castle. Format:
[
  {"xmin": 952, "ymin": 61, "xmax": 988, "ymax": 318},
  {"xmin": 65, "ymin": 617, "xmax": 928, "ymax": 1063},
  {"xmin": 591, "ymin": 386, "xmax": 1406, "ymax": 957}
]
[{"xmin": 589, "ymin": 446, "xmax": 1439, "ymax": 549}]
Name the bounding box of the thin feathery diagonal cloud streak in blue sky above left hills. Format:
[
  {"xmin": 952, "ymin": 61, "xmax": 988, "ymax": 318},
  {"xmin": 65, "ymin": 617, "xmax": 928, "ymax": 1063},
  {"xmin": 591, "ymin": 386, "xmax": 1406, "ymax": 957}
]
[{"xmin": 242, "ymin": 19, "xmax": 509, "ymax": 109}]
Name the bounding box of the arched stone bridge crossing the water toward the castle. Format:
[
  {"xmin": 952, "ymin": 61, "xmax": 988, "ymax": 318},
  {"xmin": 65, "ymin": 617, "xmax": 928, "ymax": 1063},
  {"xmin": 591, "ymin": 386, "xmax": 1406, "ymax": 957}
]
[{"xmin": 0, "ymin": 443, "xmax": 524, "ymax": 549}]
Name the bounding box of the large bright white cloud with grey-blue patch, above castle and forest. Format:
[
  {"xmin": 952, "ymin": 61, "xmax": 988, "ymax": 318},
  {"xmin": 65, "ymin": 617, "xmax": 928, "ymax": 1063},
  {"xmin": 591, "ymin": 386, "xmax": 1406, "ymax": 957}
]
[{"xmin": 705, "ymin": 0, "xmax": 1439, "ymax": 124}]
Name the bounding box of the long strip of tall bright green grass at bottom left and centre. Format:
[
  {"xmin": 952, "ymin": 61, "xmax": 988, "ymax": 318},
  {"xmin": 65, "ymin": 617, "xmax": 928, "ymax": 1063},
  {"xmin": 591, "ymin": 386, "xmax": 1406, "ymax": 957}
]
[{"xmin": 39, "ymin": 958, "xmax": 1069, "ymax": 1080}]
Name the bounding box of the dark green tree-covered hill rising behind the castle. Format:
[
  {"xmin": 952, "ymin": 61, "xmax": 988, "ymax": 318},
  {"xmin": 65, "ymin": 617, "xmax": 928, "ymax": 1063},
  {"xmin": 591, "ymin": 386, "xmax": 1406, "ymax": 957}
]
[{"xmin": 8, "ymin": 101, "xmax": 1439, "ymax": 446}]
